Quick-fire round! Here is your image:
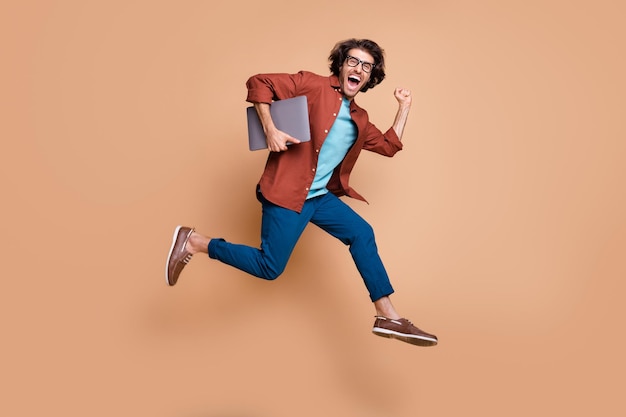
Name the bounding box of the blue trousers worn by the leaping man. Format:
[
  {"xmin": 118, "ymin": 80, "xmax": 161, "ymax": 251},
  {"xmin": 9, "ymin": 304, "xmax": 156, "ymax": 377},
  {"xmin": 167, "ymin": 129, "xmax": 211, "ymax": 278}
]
[{"xmin": 208, "ymin": 193, "xmax": 393, "ymax": 301}]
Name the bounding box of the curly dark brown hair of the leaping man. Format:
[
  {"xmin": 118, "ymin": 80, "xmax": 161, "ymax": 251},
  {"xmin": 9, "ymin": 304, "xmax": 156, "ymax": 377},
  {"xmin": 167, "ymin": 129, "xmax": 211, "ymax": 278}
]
[{"xmin": 328, "ymin": 38, "xmax": 385, "ymax": 93}]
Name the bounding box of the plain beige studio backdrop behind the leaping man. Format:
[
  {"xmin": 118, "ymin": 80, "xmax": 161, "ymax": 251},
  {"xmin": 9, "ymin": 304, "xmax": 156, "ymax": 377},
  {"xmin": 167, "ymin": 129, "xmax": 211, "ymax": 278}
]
[{"xmin": 0, "ymin": 0, "xmax": 626, "ymax": 417}]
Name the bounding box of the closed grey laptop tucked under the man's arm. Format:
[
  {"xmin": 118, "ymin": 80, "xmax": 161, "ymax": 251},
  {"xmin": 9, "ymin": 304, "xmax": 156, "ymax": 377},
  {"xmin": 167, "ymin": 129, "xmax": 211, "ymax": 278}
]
[{"xmin": 246, "ymin": 96, "xmax": 311, "ymax": 151}]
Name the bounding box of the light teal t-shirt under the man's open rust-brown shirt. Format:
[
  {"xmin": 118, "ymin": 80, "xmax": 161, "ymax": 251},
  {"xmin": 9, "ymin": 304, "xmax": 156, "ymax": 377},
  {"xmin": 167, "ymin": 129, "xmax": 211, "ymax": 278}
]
[{"xmin": 307, "ymin": 97, "xmax": 357, "ymax": 199}]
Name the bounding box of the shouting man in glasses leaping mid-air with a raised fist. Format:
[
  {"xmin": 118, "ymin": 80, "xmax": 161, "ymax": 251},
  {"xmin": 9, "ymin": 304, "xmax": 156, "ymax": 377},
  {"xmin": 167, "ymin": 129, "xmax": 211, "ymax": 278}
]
[{"xmin": 166, "ymin": 39, "xmax": 437, "ymax": 346}]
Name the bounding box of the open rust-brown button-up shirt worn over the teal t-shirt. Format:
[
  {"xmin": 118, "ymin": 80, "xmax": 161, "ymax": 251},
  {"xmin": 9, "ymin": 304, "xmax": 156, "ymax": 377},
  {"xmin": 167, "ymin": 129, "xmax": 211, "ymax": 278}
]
[{"xmin": 246, "ymin": 71, "xmax": 402, "ymax": 212}]
